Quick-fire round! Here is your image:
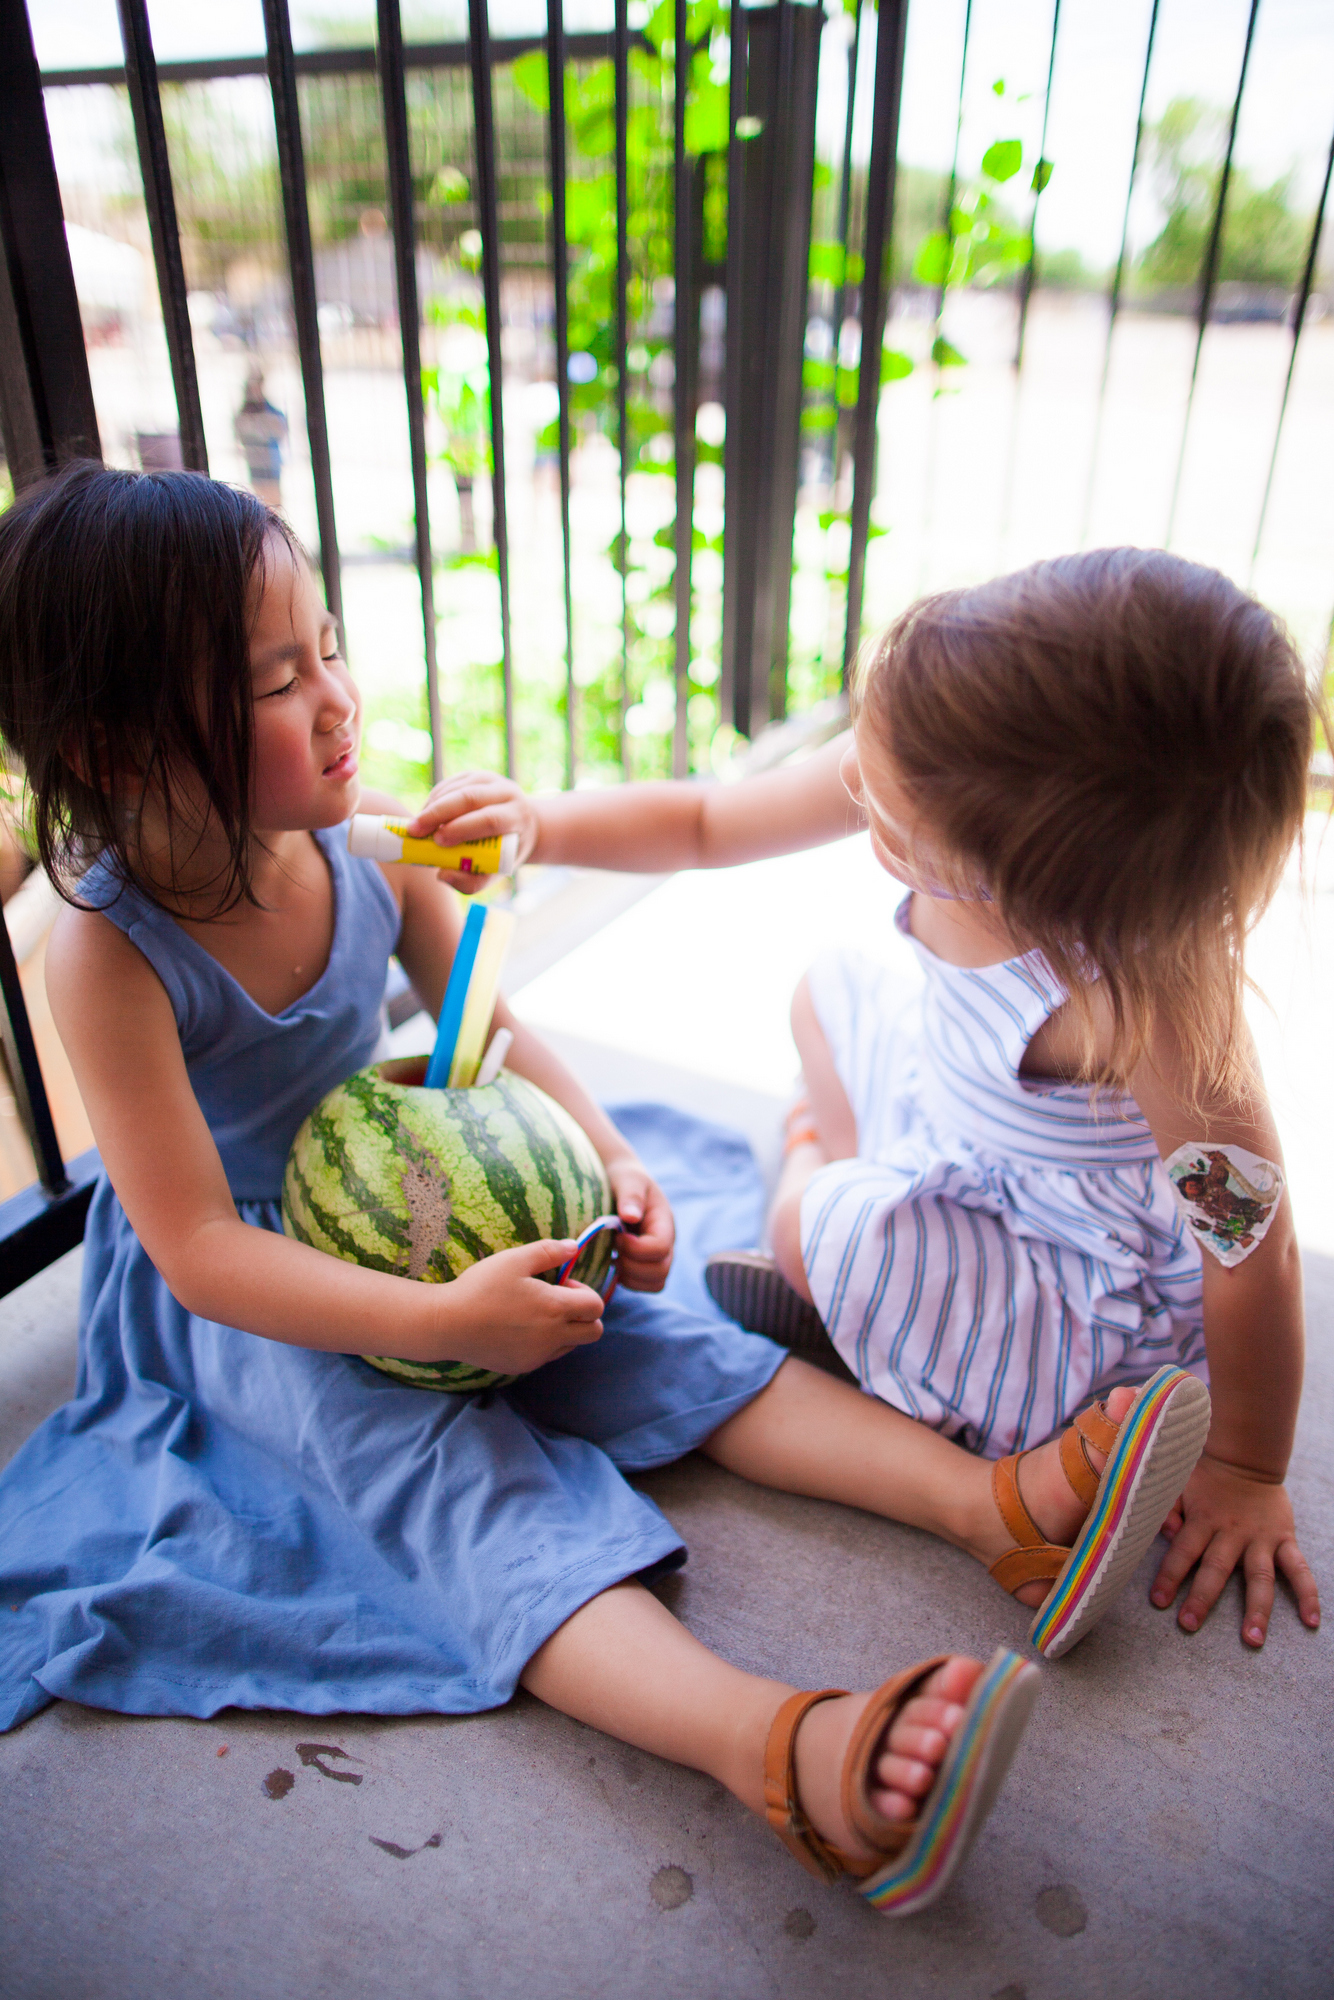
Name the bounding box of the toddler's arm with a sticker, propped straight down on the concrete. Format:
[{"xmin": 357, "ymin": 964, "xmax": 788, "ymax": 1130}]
[{"xmin": 1132, "ymin": 1032, "xmax": 1320, "ymax": 1646}]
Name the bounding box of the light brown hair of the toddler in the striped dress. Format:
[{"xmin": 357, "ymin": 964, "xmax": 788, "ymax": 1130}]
[{"xmin": 854, "ymin": 548, "xmax": 1318, "ymax": 1106}]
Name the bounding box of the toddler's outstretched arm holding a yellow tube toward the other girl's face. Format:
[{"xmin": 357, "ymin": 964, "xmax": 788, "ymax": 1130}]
[{"xmin": 396, "ymin": 732, "xmax": 864, "ymax": 888}]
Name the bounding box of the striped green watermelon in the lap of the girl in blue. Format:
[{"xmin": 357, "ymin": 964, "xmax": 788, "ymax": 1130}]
[{"xmin": 282, "ymin": 1064, "xmax": 614, "ymax": 1394}]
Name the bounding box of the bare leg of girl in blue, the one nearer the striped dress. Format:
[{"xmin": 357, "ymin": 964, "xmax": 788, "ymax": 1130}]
[{"xmin": 700, "ymin": 1356, "xmax": 1134, "ymax": 1604}]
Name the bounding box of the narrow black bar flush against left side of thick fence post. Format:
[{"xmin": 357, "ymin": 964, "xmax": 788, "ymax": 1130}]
[{"xmin": 718, "ymin": 0, "xmax": 752, "ymax": 736}]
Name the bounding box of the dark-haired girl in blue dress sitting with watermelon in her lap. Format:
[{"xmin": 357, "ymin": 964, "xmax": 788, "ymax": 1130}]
[{"xmin": 0, "ymin": 466, "xmax": 1036, "ymax": 1914}]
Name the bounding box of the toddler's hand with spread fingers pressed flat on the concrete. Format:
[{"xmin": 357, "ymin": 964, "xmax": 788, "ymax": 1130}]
[{"xmin": 1150, "ymin": 1452, "xmax": 1320, "ymax": 1646}]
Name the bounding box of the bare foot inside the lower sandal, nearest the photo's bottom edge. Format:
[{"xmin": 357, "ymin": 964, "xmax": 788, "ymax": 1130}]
[{"xmin": 796, "ymin": 1654, "xmax": 982, "ymax": 1862}]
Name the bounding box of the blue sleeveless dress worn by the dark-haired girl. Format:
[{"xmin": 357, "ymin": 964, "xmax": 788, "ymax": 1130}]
[{"xmin": 0, "ymin": 828, "xmax": 784, "ymax": 1730}]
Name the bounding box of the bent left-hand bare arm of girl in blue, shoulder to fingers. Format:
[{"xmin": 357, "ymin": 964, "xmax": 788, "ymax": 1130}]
[{"xmin": 46, "ymin": 908, "xmax": 602, "ymax": 1374}]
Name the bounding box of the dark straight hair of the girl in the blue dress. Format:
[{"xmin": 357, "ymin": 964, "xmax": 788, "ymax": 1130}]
[{"xmin": 0, "ymin": 462, "xmax": 300, "ymax": 914}]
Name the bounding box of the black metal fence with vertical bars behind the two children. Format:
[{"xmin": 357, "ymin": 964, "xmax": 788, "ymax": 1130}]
[{"xmin": 0, "ymin": 0, "xmax": 1334, "ymax": 1290}]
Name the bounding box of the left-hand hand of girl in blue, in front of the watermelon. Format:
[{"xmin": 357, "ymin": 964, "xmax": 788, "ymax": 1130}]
[{"xmin": 438, "ymin": 1240, "xmax": 602, "ymax": 1374}]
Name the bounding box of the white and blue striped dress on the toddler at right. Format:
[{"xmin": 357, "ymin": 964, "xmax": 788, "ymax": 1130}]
[{"xmin": 802, "ymin": 898, "xmax": 1204, "ymax": 1458}]
